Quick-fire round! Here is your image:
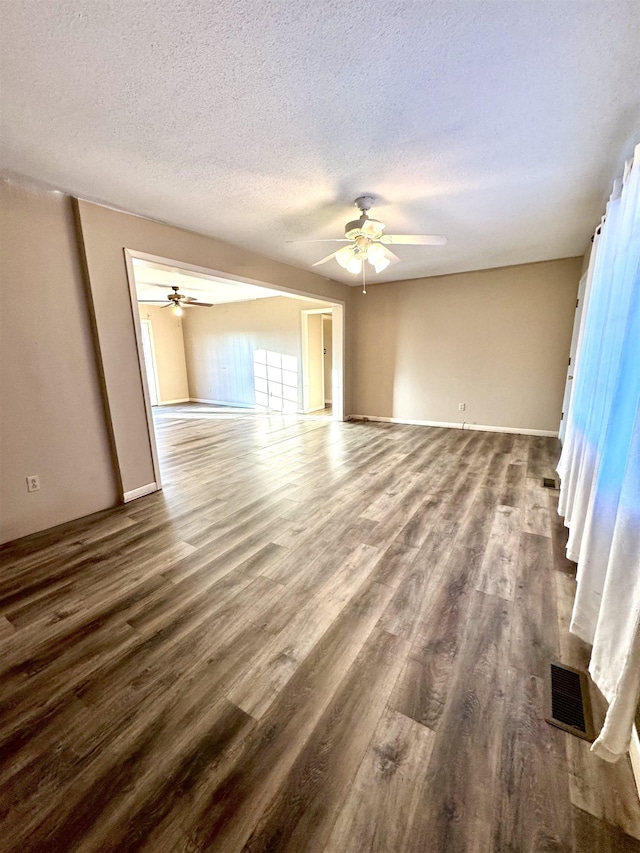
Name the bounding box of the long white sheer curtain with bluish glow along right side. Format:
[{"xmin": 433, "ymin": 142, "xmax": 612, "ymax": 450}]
[{"xmin": 558, "ymin": 145, "xmax": 640, "ymax": 761}]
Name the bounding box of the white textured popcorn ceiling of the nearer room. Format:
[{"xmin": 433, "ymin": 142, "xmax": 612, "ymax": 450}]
[{"xmin": 0, "ymin": 0, "xmax": 640, "ymax": 284}]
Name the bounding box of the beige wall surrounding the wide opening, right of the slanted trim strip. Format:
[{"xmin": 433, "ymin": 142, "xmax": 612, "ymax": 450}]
[{"xmin": 78, "ymin": 201, "xmax": 353, "ymax": 493}]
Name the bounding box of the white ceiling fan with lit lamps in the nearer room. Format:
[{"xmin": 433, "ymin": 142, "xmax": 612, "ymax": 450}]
[{"xmin": 304, "ymin": 195, "xmax": 447, "ymax": 293}]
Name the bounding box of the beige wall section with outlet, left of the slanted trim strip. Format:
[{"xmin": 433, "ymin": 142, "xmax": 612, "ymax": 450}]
[{"xmin": 0, "ymin": 181, "xmax": 118, "ymax": 542}]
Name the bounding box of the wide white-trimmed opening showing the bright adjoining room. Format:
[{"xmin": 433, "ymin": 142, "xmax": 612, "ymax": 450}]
[{"xmin": 125, "ymin": 250, "xmax": 344, "ymax": 486}]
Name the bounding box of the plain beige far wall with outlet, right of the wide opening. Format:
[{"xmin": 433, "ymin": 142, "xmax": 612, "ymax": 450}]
[{"xmin": 352, "ymin": 258, "xmax": 582, "ymax": 431}]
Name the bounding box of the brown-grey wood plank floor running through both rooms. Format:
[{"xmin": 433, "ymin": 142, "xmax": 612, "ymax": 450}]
[{"xmin": 0, "ymin": 405, "xmax": 640, "ymax": 853}]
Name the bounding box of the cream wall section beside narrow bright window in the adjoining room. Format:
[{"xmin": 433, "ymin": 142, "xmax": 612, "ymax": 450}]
[{"xmin": 138, "ymin": 305, "xmax": 189, "ymax": 403}]
